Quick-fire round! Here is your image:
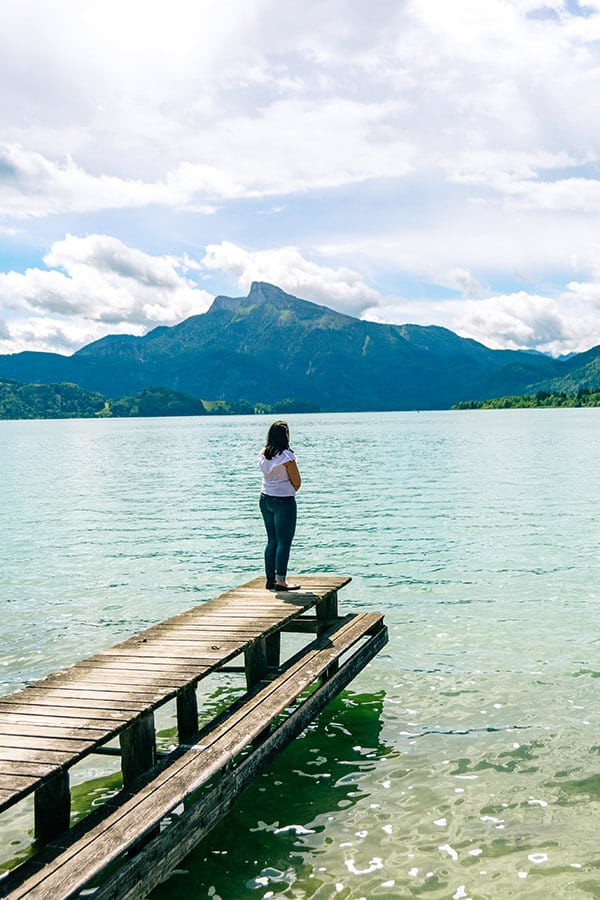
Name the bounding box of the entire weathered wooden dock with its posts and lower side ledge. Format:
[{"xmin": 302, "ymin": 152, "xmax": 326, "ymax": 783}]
[{"xmin": 0, "ymin": 576, "xmax": 387, "ymax": 900}]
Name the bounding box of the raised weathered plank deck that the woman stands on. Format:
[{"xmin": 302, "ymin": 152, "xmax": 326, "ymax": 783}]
[{"xmin": 0, "ymin": 576, "xmax": 350, "ymax": 811}]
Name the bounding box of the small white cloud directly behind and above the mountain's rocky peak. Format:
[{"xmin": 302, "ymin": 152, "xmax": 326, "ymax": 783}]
[{"xmin": 202, "ymin": 241, "xmax": 379, "ymax": 315}]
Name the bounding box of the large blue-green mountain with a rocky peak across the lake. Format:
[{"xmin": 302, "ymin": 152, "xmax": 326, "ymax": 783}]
[{"xmin": 0, "ymin": 282, "xmax": 600, "ymax": 410}]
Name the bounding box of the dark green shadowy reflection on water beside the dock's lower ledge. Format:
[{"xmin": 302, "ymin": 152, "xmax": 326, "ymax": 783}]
[{"xmin": 152, "ymin": 691, "xmax": 394, "ymax": 900}]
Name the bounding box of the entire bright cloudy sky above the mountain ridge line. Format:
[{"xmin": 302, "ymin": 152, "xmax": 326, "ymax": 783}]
[{"xmin": 0, "ymin": 0, "xmax": 600, "ymax": 356}]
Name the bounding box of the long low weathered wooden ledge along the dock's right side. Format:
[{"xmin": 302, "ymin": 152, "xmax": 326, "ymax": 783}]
[{"xmin": 0, "ymin": 613, "xmax": 387, "ymax": 900}]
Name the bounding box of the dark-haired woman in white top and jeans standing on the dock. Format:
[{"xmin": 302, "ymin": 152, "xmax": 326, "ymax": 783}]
[{"xmin": 258, "ymin": 422, "xmax": 301, "ymax": 591}]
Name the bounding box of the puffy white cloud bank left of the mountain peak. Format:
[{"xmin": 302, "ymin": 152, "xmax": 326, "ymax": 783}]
[{"xmin": 0, "ymin": 235, "xmax": 212, "ymax": 352}]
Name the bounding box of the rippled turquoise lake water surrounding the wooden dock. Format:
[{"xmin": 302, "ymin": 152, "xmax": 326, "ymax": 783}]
[{"xmin": 0, "ymin": 409, "xmax": 600, "ymax": 900}]
